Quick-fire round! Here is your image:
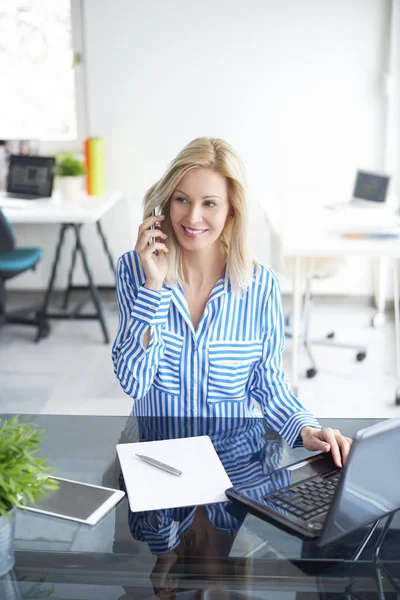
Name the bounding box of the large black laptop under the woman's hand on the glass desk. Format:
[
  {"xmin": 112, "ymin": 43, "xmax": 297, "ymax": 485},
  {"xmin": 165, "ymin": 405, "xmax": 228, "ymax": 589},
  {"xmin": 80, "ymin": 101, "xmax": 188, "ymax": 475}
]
[{"xmin": 225, "ymin": 419, "xmax": 400, "ymax": 546}]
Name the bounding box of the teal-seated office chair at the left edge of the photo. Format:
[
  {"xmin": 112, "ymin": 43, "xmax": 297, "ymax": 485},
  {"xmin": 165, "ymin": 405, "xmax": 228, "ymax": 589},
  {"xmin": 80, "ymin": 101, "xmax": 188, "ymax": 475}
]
[{"xmin": 0, "ymin": 210, "xmax": 50, "ymax": 339}]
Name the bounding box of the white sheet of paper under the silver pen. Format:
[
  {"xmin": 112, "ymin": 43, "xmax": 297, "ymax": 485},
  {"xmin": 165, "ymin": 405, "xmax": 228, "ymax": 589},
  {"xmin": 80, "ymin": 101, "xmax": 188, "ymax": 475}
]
[{"xmin": 117, "ymin": 435, "xmax": 232, "ymax": 512}]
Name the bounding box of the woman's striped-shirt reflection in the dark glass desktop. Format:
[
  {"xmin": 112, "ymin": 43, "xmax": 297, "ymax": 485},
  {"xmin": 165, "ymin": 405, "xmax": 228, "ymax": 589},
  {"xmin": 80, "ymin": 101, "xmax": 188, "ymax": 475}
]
[{"xmin": 120, "ymin": 418, "xmax": 288, "ymax": 599}]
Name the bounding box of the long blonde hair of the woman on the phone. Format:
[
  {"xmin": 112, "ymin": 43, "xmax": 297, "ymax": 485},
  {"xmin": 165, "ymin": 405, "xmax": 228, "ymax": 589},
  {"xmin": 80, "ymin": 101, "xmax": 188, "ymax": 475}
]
[{"xmin": 143, "ymin": 137, "xmax": 259, "ymax": 296}]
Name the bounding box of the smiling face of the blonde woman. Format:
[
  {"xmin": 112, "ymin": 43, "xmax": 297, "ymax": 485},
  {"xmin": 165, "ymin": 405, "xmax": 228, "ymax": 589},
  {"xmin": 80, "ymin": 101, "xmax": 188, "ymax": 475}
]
[{"xmin": 170, "ymin": 168, "xmax": 230, "ymax": 252}]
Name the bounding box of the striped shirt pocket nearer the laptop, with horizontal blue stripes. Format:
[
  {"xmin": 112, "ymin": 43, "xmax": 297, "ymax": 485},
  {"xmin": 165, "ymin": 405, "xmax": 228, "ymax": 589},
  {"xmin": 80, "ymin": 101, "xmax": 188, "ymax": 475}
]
[{"xmin": 207, "ymin": 340, "xmax": 263, "ymax": 403}]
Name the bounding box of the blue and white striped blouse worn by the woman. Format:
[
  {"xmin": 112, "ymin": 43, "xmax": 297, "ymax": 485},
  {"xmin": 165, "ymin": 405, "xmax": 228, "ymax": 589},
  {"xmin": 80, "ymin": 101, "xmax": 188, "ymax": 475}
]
[{"xmin": 112, "ymin": 251, "xmax": 319, "ymax": 446}]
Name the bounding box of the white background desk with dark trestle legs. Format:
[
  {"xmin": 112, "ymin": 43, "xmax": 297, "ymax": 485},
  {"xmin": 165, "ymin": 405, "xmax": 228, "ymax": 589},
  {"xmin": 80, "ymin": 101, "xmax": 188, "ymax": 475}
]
[{"xmin": 0, "ymin": 192, "xmax": 123, "ymax": 344}]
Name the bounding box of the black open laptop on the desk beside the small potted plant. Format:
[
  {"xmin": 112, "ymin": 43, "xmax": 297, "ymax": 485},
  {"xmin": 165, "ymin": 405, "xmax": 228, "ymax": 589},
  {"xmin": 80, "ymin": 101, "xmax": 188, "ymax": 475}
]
[{"xmin": 6, "ymin": 154, "xmax": 55, "ymax": 200}]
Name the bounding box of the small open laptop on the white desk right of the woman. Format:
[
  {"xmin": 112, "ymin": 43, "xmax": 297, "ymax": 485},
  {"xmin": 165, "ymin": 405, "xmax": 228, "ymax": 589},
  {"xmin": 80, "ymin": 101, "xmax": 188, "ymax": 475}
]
[{"xmin": 326, "ymin": 171, "xmax": 390, "ymax": 210}]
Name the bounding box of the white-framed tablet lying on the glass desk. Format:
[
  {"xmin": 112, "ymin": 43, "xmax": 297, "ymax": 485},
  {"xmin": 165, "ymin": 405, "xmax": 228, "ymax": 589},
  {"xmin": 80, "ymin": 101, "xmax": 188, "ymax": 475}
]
[{"xmin": 19, "ymin": 477, "xmax": 125, "ymax": 525}]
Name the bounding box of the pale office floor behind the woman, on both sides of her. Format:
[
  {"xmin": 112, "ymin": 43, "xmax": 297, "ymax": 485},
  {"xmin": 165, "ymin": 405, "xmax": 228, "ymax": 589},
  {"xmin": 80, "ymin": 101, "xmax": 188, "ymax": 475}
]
[{"xmin": 0, "ymin": 294, "xmax": 400, "ymax": 418}]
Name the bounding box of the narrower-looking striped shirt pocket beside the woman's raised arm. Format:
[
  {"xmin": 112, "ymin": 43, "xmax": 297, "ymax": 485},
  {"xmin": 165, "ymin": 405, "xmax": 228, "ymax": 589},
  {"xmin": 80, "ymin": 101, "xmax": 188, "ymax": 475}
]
[{"xmin": 153, "ymin": 331, "xmax": 183, "ymax": 396}]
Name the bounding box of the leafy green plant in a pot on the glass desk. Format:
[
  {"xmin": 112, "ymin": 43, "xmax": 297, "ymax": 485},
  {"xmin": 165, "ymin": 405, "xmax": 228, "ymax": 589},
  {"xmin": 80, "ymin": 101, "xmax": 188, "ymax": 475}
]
[{"xmin": 0, "ymin": 415, "xmax": 57, "ymax": 577}]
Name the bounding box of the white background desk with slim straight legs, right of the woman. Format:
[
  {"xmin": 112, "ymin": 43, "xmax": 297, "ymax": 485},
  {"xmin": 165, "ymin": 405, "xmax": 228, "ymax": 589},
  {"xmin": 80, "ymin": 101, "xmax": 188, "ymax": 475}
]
[{"xmin": 260, "ymin": 203, "xmax": 400, "ymax": 404}]
